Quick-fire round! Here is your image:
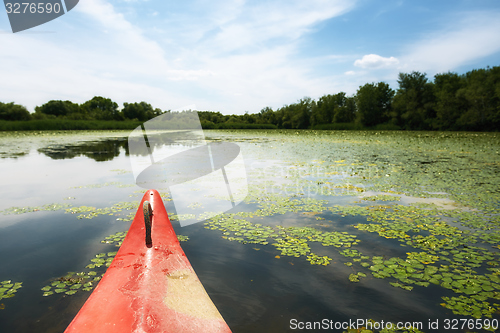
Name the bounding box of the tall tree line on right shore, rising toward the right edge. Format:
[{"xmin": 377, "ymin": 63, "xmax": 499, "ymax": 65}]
[{"xmin": 245, "ymin": 67, "xmax": 500, "ymax": 131}]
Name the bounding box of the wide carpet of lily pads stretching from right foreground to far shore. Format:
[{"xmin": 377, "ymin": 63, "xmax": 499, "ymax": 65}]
[{"xmin": 196, "ymin": 132, "xmax": 500, "ymax": 315}]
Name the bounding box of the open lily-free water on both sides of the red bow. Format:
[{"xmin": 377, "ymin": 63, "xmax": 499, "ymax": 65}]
[{"xmin": 0, "ymin": 132, "xmax": 498, "ymax": 332}]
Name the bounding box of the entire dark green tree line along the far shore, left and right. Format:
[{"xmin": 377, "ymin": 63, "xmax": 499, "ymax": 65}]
[{"xmin": 0, "ymin": 66, "xmax": 500, "ymax": 131}]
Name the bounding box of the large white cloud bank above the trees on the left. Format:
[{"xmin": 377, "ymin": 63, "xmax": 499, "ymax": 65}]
[{"xmin": 0, "ymin": 0, "xmax": 190, "ymax": 111}]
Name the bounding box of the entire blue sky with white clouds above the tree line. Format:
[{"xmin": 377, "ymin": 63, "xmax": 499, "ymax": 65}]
[{"xmin": 0, "ymin": 0, "xmax": 500, "ymax": 114}]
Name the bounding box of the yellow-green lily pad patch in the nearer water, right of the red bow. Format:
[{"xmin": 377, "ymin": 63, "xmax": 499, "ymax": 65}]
[{"xmin": 205, "ymin": 178, "xmax": 500, "ymax": 318}]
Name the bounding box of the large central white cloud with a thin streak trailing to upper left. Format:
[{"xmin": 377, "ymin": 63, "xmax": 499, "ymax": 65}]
[{"xmin": 81, "ymin": 0, "xmax": 353, "ymax": 113}]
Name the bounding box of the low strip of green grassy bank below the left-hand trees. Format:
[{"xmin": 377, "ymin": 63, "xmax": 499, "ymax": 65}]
[{"xmin": 0, "ymin": 119, "xmax": 142, "ymax": 131}]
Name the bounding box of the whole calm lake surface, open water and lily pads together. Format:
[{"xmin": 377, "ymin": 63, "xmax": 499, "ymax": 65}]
[{"xmin": 0, "ymin": 130, "xmax": 500, "ymax": 332}]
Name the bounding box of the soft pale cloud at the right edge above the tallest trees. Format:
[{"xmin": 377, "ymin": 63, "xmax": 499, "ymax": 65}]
[{"xmin": 401, "ymin": 11, "xmax": 500, "ymax": 72}]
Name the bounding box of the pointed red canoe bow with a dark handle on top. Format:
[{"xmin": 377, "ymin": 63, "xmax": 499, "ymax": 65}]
[{"xmin": 65, "ymin": 190, "xmax": 231, "ymax": 333}]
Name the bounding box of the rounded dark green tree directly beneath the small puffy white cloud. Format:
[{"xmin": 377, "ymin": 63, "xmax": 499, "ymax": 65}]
[{"xmin": 355, "ymin": 82, "xmax": 394, "ymax": 127}]
